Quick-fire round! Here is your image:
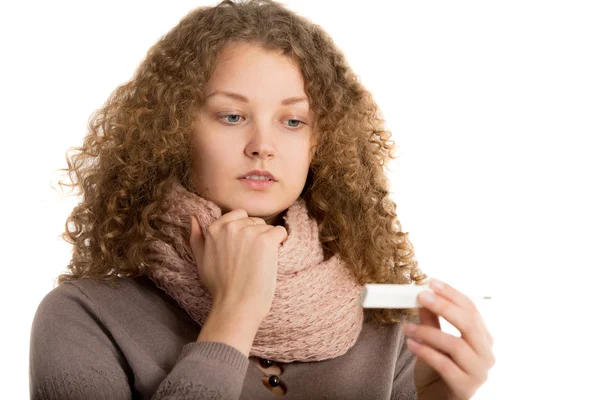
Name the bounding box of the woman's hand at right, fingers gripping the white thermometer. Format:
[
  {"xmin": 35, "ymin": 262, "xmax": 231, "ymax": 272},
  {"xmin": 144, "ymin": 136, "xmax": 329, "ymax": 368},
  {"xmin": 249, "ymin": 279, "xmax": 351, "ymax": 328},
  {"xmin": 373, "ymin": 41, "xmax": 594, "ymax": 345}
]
[{"xmin": 404, "ymin": 279, "xmax": 495, "ymax": 400}]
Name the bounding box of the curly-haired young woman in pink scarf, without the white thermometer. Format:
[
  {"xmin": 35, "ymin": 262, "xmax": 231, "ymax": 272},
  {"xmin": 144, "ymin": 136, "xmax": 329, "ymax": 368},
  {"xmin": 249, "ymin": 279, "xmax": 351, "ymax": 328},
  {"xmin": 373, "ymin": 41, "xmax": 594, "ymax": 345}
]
[{"xmin": 30, "ymin": 1, "xmax": 494, "ymax": 399}]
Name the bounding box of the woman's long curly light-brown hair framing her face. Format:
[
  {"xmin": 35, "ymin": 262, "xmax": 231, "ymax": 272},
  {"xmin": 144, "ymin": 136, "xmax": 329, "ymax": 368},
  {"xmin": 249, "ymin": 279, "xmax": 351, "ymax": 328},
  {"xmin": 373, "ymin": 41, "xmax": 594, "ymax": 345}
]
[{"xmin": 57, "ymin": 0, "xmax": 427, "ymax": 324}]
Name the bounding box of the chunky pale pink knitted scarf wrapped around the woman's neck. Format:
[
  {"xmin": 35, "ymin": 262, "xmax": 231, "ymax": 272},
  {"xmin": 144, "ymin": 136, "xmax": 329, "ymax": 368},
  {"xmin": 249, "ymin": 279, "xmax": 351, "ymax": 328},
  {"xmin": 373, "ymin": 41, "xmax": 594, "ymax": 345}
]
[{"xmin": 146, "ymin": 182, "xmax": 363, "ymax": 362}]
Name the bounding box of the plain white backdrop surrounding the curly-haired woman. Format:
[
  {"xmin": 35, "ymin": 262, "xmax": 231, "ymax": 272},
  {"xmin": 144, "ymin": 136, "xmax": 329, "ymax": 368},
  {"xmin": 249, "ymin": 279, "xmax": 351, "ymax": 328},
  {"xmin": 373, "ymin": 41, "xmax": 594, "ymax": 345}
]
[{"xmin": 0, "ymin": 0, "xmax": 600, "ymax": 399}]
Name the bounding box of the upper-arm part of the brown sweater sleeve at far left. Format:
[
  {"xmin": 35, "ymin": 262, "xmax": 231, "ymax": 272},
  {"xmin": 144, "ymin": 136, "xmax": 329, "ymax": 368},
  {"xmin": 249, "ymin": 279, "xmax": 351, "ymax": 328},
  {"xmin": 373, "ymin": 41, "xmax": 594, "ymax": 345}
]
[{"xmin": 29, "ymin": 283, "xmax": 131, "ymax": 400}]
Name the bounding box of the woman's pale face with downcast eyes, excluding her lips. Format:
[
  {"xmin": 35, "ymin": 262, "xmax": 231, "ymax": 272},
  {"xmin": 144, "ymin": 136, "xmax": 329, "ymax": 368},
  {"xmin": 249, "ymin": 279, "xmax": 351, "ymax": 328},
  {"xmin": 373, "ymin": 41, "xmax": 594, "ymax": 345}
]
[{"xmin": 192, "ymin": 43, "xmax": 314, "ymax": 225}]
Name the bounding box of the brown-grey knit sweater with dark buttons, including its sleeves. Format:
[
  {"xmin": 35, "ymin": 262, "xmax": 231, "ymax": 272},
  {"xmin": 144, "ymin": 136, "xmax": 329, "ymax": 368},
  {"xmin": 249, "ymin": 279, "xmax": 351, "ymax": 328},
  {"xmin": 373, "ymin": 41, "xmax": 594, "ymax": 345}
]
[{"xmin": 29, "ymin": 277, "xmax": 417, "ymax": 400}]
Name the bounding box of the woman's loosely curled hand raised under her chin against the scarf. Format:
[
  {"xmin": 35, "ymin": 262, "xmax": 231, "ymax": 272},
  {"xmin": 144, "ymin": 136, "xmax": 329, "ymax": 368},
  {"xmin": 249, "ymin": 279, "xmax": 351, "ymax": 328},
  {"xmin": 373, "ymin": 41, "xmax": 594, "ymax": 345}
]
[{"xmin": 190, "ymin": 209, "xmax": 288, "ymax": 323}]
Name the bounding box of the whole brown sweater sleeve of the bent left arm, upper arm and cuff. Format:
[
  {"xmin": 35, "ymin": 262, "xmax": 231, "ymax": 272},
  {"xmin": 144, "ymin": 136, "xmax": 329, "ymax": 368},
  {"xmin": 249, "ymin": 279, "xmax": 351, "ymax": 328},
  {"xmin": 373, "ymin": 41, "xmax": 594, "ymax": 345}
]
[{"xmin": 29, "ymin": 282, "xmax": 249, "ymax": 400}]
